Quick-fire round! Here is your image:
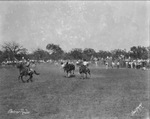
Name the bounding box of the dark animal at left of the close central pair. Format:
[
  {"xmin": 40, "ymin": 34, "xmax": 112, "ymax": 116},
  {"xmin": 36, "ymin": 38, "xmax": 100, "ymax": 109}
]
[{"xmin": 63, "ymin": 62, "xmax": 75, "ymax": 77}]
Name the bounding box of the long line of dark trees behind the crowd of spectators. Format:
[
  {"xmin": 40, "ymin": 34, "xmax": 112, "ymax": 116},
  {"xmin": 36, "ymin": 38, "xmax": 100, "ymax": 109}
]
[{"xmin": 0, "ymin": 41, "xmax": 150, "ymax": 63}]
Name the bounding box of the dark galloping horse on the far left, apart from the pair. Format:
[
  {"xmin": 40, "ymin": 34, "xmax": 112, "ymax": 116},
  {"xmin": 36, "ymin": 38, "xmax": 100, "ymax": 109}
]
[{"xmin": 17, "ymin": 63, "xmax": 39, "ymax": 83}]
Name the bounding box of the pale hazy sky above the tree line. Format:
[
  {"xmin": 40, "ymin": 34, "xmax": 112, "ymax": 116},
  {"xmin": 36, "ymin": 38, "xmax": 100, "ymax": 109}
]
[{"xmin": 0, "ymin": 1, "xmax": 150, "ymax": 51}]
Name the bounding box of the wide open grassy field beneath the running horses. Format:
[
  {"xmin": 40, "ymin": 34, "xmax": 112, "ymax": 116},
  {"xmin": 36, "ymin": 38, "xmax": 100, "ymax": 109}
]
[{"xmin": 0, "ymin": 64, "xmax": 150, "ymax": 119}]
